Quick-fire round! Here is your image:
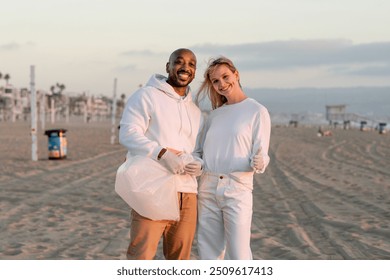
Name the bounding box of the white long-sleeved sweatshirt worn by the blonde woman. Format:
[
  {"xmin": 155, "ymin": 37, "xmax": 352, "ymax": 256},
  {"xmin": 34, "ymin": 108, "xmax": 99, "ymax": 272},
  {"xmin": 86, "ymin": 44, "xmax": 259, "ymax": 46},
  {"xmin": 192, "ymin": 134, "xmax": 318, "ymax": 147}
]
[{"xmin": 197, "ymin": 98, "xmax": 271, "ymax": 174}]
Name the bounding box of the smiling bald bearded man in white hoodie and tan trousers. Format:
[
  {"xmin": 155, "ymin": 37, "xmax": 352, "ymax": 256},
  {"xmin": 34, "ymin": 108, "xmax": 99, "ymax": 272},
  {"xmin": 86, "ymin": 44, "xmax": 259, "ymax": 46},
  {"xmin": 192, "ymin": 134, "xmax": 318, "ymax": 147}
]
[{"xmin": 119, "ymin": 49, "xmax": 203, "ymax": 260}]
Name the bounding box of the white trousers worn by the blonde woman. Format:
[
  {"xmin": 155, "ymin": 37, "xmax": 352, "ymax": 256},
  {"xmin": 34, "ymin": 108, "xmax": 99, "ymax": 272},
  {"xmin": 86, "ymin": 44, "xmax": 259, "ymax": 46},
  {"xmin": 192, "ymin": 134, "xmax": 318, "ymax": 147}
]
[{"xmin": 197, "ymin": 172, "xmax": 253, "ymax": 260}]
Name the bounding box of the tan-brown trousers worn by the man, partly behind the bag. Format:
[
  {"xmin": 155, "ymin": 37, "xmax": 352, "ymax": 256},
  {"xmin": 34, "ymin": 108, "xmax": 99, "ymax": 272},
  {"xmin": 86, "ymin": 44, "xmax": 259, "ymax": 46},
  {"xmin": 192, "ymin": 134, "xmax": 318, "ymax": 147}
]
[{"xmin": 127, "ymin": 193, "xmax": 197, "ymax": 260}]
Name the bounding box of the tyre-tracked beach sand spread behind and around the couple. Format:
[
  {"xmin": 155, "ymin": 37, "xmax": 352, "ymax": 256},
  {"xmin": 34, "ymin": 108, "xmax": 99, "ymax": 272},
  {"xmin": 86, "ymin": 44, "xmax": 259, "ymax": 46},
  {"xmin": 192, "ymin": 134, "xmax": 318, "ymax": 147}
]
[{"xmin": 0, "ymin": 122, "xmax": 390, "ymax": 260}]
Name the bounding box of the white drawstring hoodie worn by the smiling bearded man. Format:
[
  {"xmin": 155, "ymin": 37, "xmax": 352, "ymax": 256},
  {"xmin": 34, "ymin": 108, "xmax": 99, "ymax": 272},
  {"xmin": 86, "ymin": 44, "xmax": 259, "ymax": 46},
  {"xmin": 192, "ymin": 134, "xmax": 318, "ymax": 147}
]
[{"xmin": 119, "ymin": 74, "xmax": 203, "ymax": 193}]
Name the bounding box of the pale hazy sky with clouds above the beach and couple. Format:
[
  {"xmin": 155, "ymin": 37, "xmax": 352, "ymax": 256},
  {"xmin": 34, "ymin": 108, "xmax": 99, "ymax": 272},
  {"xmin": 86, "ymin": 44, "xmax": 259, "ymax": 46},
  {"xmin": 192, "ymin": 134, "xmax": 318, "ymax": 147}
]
[{"xmin": 0, "ymin": 0, "xmax": 390, "ymax": 96}]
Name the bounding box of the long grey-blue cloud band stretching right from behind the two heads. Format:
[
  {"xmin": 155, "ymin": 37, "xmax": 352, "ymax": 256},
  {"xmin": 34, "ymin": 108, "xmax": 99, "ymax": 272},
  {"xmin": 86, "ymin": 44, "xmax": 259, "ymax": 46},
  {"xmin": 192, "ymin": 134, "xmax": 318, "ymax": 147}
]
[{"xmin": 193, "ymin": 40, "xmax": 390, "ymax": 74}]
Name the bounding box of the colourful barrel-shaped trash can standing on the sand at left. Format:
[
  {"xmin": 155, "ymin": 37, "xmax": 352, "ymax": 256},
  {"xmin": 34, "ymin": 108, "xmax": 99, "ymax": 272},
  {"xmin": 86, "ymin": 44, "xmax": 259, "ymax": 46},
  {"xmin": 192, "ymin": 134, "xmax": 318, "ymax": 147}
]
[{"xmin": 45, "ymin": 129, "xmax": 67, "ymax": 159}]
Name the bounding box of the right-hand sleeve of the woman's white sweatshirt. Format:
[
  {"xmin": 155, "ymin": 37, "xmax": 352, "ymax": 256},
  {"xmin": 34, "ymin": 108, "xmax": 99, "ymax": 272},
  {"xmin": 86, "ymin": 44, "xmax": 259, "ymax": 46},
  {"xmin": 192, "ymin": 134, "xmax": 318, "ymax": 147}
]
[{"xmin": 251, "ymin": 106, "xmax": 271, "ymax": 173}]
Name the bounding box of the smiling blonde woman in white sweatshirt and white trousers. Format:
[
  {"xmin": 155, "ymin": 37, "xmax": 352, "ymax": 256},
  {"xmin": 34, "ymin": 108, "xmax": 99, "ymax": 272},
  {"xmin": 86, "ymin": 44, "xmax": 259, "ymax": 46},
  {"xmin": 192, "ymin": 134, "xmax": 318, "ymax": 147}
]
[{"xmin": 195, "ymin": 57, "xmax": 271, "ymax": 260}]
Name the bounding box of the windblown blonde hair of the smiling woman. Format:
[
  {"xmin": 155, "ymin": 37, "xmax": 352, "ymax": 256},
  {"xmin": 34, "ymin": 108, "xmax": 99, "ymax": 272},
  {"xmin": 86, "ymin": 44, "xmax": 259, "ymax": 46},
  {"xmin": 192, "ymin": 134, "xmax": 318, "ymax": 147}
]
[{"xmin": 195, "ymin": 56, "xmax": 241, "ymax": 110}]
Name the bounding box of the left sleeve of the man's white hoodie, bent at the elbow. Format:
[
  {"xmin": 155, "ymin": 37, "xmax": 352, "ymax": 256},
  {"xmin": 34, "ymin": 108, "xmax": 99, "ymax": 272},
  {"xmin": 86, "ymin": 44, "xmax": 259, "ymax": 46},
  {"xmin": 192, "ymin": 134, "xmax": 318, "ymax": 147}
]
[{"xmin": 119, "ymin": 89, "xmax": 163, "ymax": 159}]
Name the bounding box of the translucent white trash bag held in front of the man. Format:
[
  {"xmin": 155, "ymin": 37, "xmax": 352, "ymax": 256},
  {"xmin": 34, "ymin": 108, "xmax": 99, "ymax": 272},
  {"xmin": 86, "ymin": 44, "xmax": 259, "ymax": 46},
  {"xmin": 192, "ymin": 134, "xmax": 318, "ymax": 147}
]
[{"xmin": 115, "ymin": 156, "xmax": 180, "ymax": 221}]
